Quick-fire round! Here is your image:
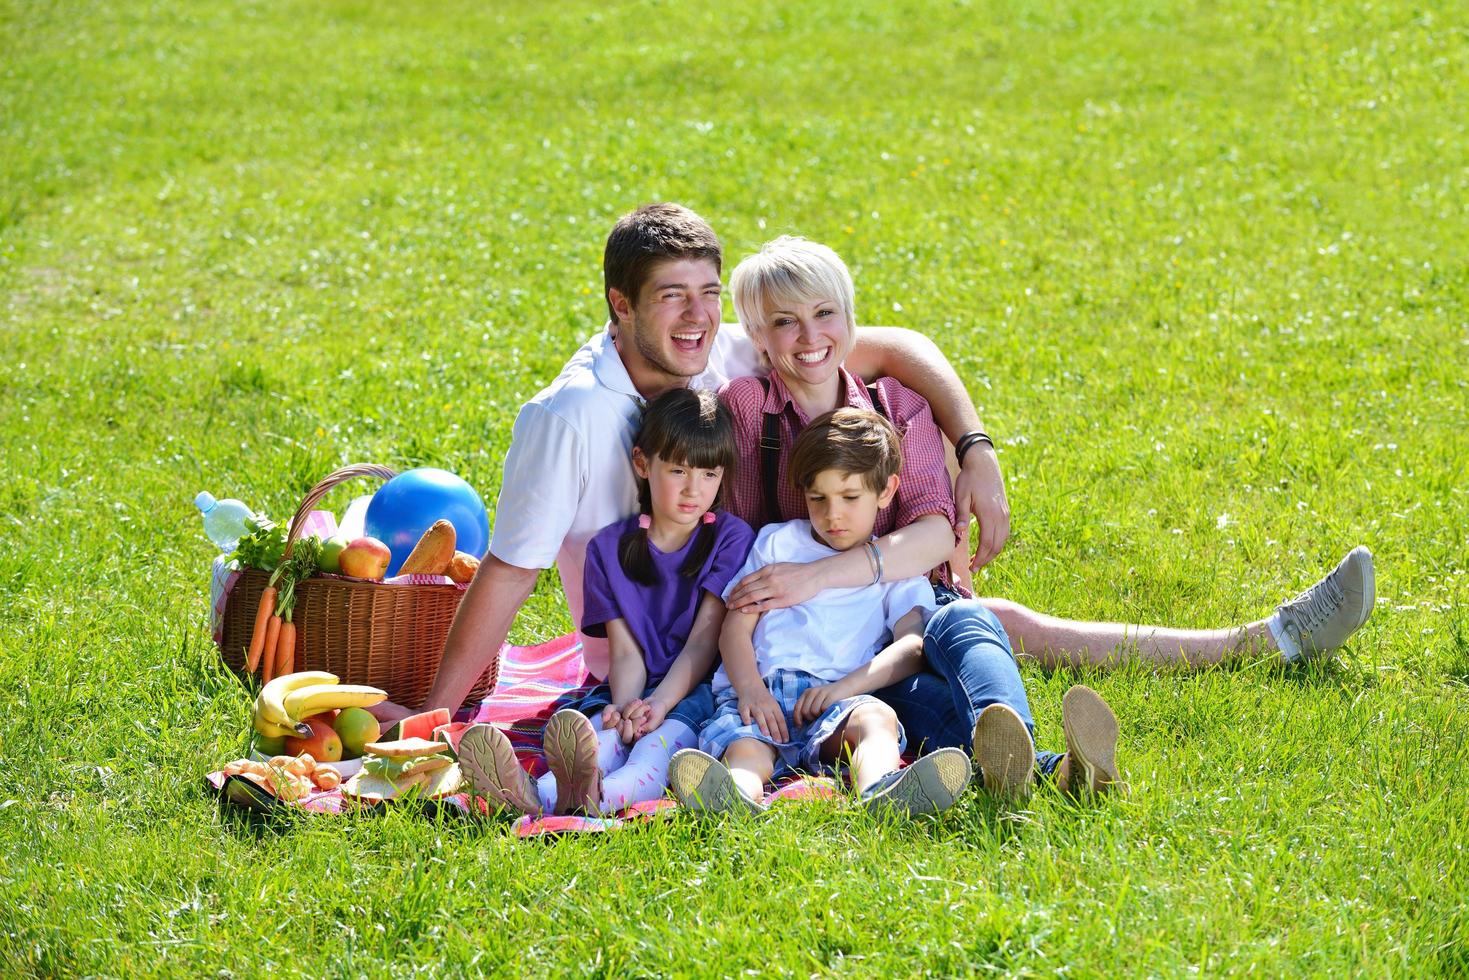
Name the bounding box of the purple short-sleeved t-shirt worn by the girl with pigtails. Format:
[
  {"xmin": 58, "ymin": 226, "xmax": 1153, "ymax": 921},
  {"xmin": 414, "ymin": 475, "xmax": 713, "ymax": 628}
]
[{"xmin": 582, "ymin": 511, "xmax": 755, "ymax": 685}]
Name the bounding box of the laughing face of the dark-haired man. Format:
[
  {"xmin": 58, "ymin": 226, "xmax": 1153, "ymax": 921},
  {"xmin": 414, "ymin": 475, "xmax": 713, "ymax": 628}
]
[{"xmin": 611, "ymin": 259, "xmax": 721, "ymax": 398}]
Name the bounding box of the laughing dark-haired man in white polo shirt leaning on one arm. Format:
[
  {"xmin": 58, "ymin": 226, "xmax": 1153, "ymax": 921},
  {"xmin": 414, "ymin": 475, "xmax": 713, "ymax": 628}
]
[{"xmin": 423, "ymin": 204, "xmax": 1009, "ymax": 708}]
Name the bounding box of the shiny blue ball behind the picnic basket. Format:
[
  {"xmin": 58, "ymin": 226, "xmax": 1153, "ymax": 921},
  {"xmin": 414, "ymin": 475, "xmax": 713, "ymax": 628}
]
[{"xmin": 364, "ymin": 467, "xmax": 489, "ymax": 576}]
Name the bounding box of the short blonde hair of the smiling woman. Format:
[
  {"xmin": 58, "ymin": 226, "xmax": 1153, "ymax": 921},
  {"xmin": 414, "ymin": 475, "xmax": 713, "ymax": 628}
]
[{"xmin": 730, "ymin": 235, "xmax": 856, "ymax": 360}]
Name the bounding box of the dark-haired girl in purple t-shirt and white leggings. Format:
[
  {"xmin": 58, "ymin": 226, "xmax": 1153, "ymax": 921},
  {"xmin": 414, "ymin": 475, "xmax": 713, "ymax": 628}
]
[{"xmin": 460, "ymin": 388, "xmax": 755, "ymax": 814}]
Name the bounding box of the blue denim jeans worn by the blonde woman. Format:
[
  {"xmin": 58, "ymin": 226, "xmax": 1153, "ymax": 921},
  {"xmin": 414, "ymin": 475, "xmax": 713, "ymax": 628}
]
[{"xmin": 876, "ymin": 599, "xmax": 1061, "ymax": 773}]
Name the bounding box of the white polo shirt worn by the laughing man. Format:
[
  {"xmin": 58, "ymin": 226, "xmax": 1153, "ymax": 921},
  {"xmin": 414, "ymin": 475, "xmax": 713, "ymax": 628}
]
[{"xmin": 489, "ymin": 323, "xmax": 758, "ymax": 677}]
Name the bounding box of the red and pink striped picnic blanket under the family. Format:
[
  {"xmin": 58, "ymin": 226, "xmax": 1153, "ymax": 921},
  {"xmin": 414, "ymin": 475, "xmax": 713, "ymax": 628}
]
[{"xmin": 213, "ymin": 633, "xmax": 840, "ymax": 837}]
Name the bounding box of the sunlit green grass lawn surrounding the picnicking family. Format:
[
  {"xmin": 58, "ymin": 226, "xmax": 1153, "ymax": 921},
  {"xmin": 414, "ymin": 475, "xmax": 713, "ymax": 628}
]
[{"xmin": 0, "ymin": 0, "xmax": 1469, "ymax": 976}]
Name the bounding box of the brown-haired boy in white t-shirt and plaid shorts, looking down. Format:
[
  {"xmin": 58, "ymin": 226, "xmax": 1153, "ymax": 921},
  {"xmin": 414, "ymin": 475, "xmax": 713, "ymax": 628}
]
[{"xmin": 670, "ymin": 408, "xmax": 970, "ymax": 815}]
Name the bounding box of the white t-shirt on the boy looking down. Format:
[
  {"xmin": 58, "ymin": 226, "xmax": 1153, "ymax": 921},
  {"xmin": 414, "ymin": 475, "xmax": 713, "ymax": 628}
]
[{"xmin": 714, "ymin": 520, "xmax": 939, "ymax": 693}]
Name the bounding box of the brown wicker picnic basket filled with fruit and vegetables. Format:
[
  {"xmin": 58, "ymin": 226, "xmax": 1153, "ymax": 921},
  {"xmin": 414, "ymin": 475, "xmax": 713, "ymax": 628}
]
[{"xmin": 219, "ymin": 463, "xmax": 499, "ymax": 708}]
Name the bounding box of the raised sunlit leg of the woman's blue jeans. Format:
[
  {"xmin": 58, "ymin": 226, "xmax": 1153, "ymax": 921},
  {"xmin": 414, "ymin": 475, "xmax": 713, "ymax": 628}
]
[{"xmin": 923, "ymin": 599, "xmax": 1061, "ymax": 773}]
